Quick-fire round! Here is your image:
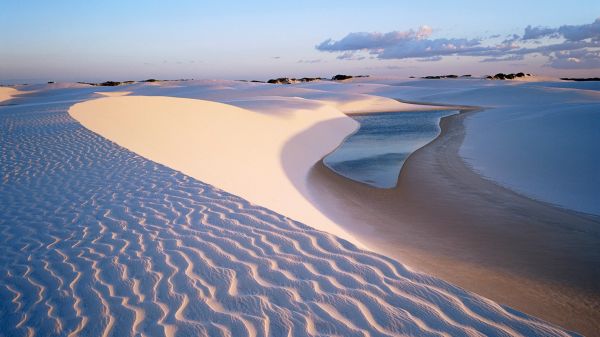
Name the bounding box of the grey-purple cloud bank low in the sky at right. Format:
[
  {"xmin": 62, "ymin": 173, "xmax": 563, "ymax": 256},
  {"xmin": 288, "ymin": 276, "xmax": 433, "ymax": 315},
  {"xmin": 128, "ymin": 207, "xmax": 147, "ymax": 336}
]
[{"xmin": 316, "ymin": 18, "xmax": 600, "ymax": 69}]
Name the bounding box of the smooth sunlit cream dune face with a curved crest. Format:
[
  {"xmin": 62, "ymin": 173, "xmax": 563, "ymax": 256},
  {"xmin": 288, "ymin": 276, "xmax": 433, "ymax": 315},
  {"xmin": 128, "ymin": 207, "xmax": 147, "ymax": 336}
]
[{"xmin": 69, "ymin": 89, "xmax": 436, "ymax": 245}]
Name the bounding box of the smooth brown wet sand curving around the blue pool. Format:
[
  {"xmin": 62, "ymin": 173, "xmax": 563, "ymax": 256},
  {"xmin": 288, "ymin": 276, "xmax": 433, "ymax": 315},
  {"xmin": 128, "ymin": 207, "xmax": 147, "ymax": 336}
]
[{"xmin": 308, "ymin": 107, "xmax": 600, "ymax": 336}]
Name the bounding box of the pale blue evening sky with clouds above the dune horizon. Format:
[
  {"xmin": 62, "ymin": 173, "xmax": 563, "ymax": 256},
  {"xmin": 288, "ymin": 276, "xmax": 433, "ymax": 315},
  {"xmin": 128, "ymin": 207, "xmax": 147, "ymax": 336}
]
[{"xmin": 0, "ymin": 0, "xmax": 600, "ymax": 83}]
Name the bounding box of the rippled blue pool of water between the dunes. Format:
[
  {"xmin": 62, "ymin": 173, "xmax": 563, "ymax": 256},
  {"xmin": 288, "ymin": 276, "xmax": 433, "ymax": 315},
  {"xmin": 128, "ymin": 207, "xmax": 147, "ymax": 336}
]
[{"xmin": 323, "ymin": 110, "xmax": 458, "ymax": 188}]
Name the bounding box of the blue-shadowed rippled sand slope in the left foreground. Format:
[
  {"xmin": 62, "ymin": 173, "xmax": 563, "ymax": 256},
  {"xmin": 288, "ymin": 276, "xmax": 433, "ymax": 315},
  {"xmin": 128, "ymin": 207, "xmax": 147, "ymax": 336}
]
[{"xmin": 0, "ymin": 95, "xmax": 567, "ymax": 336}]
